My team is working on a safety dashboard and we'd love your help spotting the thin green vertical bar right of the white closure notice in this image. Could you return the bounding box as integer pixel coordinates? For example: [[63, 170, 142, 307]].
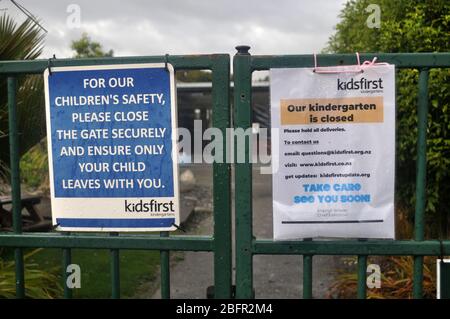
[[413, 69, 429, 298]]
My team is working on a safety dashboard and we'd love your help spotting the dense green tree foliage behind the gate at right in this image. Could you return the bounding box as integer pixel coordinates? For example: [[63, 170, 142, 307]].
[[325, 0, 450, 235]]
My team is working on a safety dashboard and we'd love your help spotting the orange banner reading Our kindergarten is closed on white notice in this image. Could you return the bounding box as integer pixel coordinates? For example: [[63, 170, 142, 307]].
[[280, 96, 384, 125]]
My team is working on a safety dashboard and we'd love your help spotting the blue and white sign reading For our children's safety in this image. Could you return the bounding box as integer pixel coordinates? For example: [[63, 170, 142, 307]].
[[44, 63, 179, 232]]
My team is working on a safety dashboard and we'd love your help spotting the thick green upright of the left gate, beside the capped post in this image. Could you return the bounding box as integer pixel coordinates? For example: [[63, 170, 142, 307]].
[[212, 55, 232, 299]]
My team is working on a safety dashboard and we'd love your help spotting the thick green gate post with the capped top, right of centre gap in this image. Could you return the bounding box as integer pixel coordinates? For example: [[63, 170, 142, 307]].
[[233, 46, 254, 298]]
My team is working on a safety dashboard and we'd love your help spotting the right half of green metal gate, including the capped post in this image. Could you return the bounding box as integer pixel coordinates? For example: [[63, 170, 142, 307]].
[[233, 46, 450, 298]]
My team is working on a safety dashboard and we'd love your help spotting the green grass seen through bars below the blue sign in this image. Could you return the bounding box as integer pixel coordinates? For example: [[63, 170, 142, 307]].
[[25, 249, 159, 298]]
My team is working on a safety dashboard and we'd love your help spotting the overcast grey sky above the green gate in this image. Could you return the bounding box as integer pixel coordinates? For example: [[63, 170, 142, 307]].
[[0, 0, 346, 58]]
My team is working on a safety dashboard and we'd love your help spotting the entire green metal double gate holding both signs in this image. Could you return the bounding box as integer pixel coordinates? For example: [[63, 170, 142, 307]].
[[0, 50, 450, 298]]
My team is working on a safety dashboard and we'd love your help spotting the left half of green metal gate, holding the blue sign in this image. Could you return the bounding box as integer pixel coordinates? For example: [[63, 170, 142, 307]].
[[0, 54, 232, 298]]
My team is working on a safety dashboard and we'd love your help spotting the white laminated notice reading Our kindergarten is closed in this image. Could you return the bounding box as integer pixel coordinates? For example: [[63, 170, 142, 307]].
[[270, 64, 395, 240]]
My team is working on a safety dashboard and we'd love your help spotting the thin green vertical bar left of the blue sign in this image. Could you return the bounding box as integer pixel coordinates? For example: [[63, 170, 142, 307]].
[[8, 77, 25, 298]]
